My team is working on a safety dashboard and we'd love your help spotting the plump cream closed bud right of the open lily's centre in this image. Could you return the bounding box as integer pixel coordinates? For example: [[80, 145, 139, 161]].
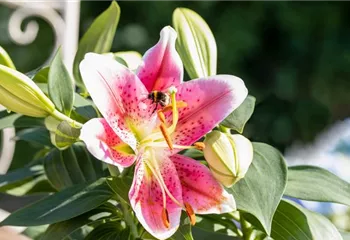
[[203, 131, 253, 187]]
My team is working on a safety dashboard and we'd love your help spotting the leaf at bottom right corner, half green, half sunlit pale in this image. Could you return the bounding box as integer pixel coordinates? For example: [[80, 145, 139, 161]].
[[271, 200, 342, 240]]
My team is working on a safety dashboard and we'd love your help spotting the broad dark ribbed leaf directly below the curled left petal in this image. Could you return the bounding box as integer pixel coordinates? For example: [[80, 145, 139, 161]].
[[44, 143, 103, 190]]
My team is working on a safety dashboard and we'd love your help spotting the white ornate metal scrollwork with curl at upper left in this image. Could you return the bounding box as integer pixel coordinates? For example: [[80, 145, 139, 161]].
[[0, 0, 80, 174]]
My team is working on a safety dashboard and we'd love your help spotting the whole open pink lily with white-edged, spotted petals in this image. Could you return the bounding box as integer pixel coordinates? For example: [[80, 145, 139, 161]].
[[80, 27, 247, 239]]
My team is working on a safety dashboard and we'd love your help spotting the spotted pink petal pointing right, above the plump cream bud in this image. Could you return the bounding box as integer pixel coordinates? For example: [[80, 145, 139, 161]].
[[171, 75, 248, 145]]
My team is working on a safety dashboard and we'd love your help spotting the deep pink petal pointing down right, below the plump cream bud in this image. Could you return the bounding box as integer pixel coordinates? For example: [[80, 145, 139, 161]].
[[170, 154, 236, 214]]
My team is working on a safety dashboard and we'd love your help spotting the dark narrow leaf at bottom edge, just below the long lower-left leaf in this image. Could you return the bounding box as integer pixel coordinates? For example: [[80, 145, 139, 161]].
[[41, 202, 117, 240]]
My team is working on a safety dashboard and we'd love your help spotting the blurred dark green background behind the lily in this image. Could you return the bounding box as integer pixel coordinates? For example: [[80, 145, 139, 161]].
[[0, 0, 350, 154]]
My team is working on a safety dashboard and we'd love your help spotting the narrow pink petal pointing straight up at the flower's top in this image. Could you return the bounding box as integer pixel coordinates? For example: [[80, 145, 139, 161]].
[[137, 26, 183, 91]]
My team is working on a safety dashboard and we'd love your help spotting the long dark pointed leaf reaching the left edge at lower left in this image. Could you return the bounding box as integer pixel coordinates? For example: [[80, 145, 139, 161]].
[[1, 178, 113, 226]]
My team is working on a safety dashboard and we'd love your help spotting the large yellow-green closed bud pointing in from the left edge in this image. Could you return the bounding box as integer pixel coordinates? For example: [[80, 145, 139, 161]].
[[0, 65, 55, 117]]
